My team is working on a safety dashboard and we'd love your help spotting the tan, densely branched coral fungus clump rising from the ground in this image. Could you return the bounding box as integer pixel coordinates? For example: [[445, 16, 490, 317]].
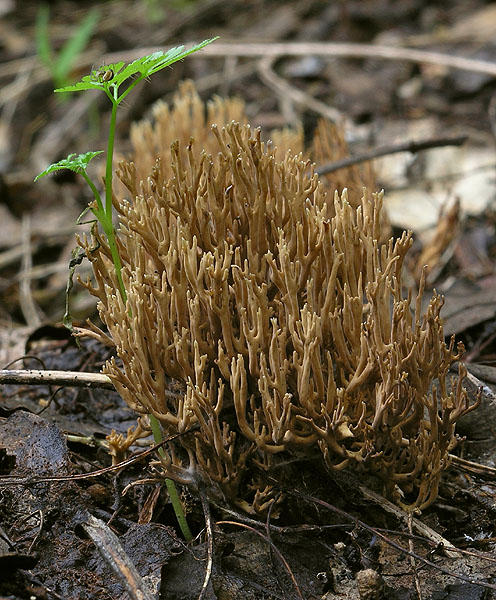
[[81, 82, 476, 511]]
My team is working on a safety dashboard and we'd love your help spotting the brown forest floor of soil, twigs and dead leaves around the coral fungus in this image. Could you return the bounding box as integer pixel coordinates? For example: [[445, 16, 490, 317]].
[[0, 0, 496, 600]]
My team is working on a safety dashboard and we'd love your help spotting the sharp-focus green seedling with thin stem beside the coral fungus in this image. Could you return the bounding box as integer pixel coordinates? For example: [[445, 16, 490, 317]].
[[35, 38, 217, 541]]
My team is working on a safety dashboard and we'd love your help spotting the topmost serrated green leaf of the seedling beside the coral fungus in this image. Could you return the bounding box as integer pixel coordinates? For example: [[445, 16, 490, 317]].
[[55, 37, 217, 92]]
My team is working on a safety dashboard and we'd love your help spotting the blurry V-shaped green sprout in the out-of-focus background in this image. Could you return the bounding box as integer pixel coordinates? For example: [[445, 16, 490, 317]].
[[35, 4, 100, 88]]
